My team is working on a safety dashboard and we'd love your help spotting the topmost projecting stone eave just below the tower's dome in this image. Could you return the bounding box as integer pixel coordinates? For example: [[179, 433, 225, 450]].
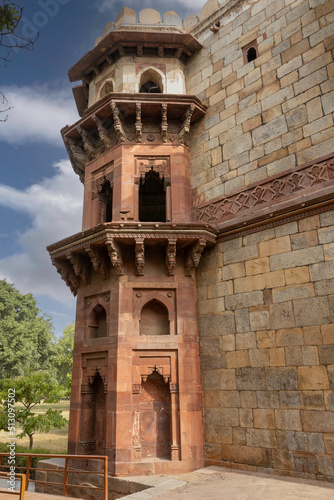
[[68, 28, 202, 82]]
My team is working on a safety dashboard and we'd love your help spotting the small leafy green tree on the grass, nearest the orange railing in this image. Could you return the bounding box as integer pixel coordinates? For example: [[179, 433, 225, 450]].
[[0, 372, 68, 449]]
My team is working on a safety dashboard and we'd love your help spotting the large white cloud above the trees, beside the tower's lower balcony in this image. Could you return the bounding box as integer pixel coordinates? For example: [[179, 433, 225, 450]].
[[0, 160, 83, 304]]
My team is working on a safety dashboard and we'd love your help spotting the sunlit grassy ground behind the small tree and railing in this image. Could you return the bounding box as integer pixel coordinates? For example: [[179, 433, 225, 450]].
[[0, 401, 70, 454]]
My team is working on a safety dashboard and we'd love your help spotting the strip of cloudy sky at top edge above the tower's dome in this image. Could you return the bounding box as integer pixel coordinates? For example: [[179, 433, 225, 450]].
[[97, 0, 206, 15]]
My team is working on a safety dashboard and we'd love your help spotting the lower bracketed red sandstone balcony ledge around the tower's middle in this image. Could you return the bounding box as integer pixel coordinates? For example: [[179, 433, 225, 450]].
[[48, 222, 216, 295]]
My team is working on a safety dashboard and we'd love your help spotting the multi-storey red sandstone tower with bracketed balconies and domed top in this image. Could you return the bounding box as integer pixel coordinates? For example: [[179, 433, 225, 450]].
[[48, 8, 215, 475]]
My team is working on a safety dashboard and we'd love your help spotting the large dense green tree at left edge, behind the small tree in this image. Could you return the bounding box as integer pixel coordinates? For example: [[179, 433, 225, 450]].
[[0, 280, 56, 378]]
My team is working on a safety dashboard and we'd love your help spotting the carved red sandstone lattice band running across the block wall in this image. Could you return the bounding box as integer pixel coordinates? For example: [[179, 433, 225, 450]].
[[196, 153, 334, 238]]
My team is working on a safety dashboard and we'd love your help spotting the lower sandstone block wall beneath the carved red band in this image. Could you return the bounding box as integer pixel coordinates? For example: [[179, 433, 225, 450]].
[[198, 211, 334, 480]]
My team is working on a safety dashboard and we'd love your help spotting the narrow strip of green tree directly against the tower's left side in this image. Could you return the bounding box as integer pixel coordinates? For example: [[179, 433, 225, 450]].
[[54, 323, 74, 393]]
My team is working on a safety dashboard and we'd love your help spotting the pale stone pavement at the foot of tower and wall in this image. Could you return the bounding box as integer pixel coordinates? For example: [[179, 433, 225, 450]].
[[123, 467, 334, 500]]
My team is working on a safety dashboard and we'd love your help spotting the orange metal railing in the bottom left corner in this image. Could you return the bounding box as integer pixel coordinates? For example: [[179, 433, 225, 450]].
[[0, 453, 108, 500]]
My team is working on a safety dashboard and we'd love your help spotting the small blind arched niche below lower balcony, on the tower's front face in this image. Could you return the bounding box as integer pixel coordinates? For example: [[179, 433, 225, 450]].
[[140, 300, 170, 335]]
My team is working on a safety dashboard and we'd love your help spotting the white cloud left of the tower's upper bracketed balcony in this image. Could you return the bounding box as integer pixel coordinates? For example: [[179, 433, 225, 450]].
[[0, 85, 79, 146]]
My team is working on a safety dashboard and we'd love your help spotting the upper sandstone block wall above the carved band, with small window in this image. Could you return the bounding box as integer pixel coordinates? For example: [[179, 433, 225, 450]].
[[186, 0, 334, 203]]
